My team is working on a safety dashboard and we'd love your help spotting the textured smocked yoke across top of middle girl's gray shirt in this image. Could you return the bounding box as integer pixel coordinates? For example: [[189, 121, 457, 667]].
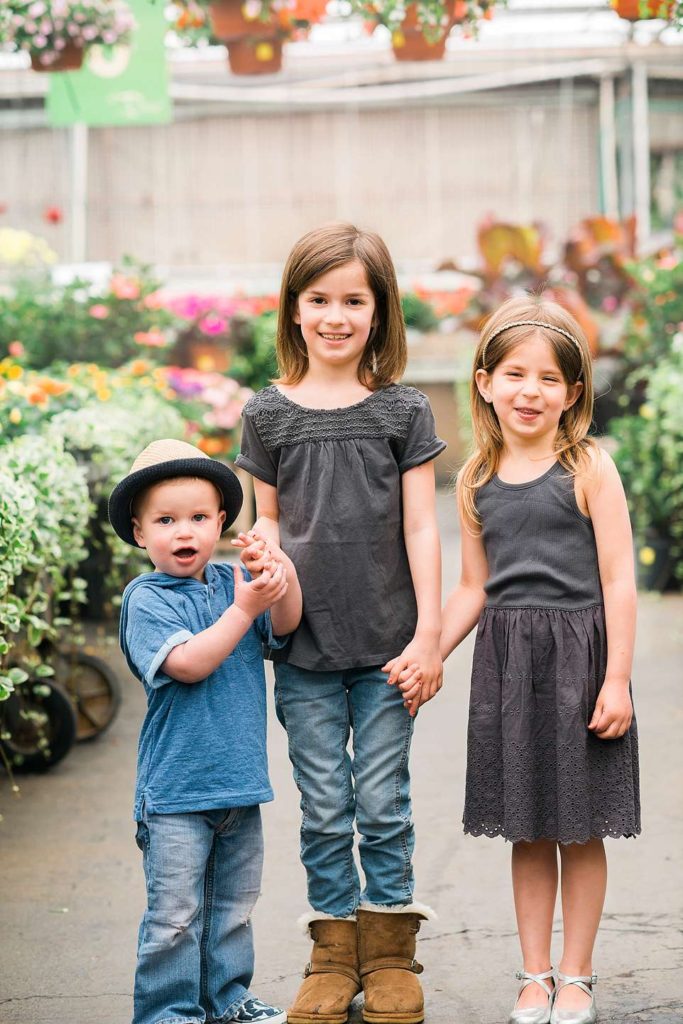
[[245, 384, 427, 451]]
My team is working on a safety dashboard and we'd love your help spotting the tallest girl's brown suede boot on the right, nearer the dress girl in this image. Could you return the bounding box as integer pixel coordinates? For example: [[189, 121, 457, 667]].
[[357, 910, 426, 1024]]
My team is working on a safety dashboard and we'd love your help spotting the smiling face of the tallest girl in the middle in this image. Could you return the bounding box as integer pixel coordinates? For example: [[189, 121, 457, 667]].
[[294, 260, 375, 367]]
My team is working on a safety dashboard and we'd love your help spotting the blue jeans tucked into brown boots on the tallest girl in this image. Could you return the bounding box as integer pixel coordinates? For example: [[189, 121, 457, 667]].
[[275, 664, 415, 918]]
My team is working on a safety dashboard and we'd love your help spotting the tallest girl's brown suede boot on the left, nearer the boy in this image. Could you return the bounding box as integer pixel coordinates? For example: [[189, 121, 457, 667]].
[[287, 920, 360, 1024]]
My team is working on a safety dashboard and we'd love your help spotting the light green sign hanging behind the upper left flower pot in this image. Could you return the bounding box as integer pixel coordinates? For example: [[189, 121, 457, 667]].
[[46, 0, 171, 126]]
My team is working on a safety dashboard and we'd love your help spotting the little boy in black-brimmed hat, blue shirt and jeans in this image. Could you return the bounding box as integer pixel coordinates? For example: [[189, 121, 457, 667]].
[[109, 440, 301, 1024]]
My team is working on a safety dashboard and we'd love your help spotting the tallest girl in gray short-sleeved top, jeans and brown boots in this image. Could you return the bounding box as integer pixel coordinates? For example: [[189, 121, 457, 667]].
[[237, 224, 445, 1024]]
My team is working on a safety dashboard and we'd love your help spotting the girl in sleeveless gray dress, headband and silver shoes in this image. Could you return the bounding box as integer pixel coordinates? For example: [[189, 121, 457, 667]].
[[441, 297, 640, 1024]]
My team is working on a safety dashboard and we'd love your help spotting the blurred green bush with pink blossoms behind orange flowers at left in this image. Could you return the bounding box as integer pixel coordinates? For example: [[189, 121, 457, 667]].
[[0, 260, 178, 369]]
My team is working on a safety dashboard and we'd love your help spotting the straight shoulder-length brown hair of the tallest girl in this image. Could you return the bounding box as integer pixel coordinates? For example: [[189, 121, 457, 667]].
[[276, 223, 408, 391]]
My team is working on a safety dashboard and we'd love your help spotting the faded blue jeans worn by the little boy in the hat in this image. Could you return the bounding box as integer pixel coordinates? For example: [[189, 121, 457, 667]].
[[133, 807, 263, 1024]]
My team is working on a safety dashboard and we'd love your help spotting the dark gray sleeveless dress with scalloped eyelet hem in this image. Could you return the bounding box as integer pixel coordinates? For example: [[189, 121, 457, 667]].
[[463, 463, 640, 843]]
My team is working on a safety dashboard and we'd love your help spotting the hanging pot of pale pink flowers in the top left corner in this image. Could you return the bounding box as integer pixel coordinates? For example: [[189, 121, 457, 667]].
[[0, 0, 135, 72]]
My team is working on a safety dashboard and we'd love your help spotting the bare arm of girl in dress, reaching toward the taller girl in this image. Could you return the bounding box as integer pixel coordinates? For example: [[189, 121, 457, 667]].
[[441, 480, 488, 660]]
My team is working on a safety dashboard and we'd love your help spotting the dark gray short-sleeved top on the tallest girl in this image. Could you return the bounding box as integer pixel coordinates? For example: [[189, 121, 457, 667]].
[[237, 384, 445, 671]]
